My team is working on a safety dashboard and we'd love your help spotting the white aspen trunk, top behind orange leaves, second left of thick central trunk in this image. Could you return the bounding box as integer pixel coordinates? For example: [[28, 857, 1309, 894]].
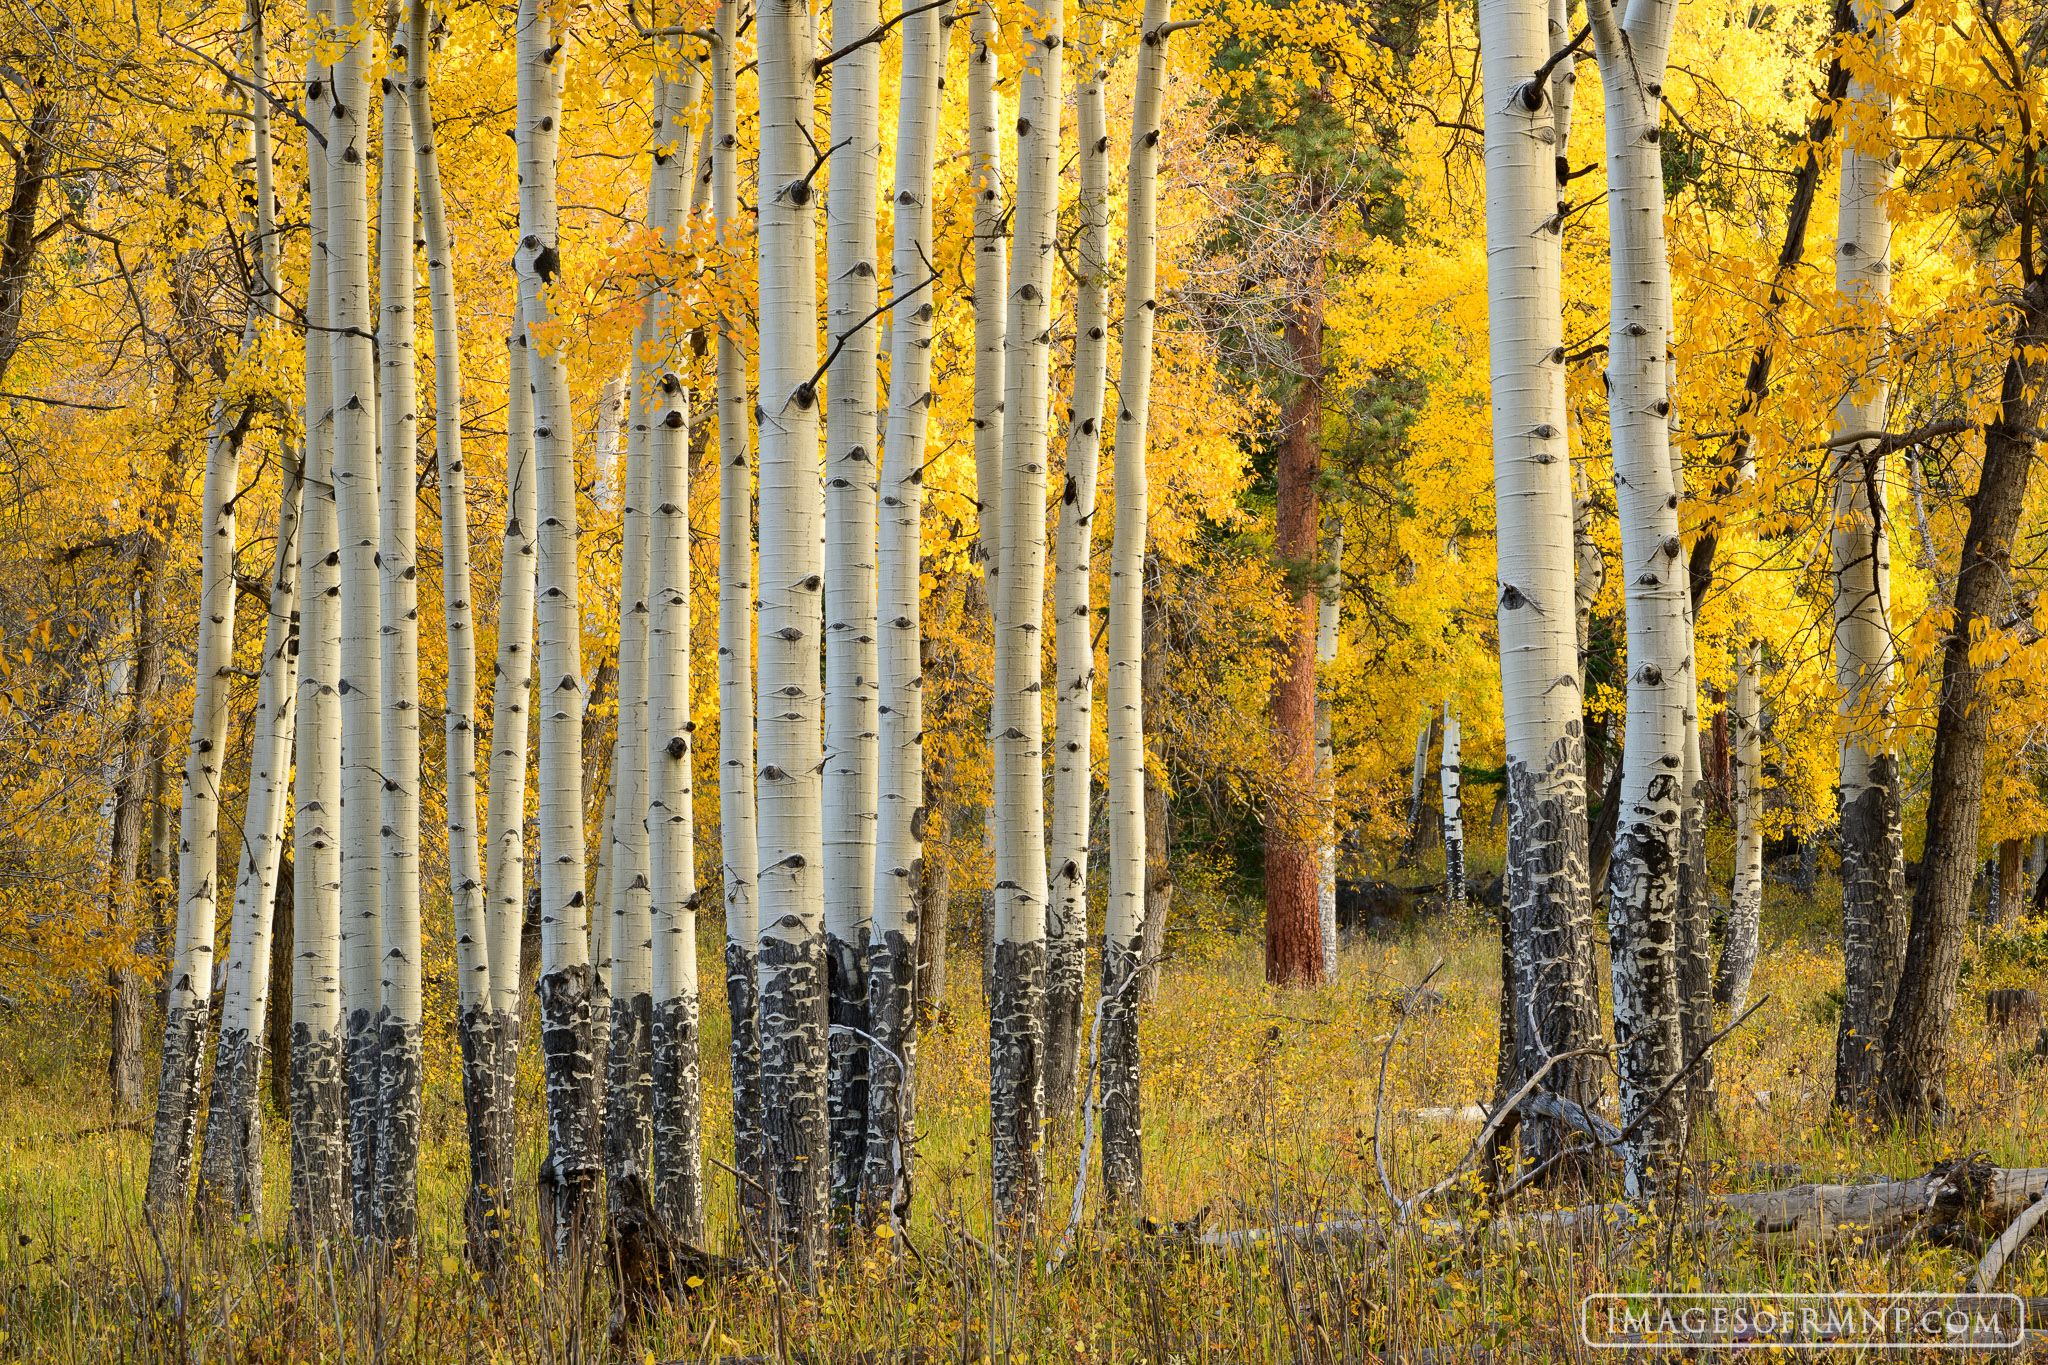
[[643, 368, 707, 1246]]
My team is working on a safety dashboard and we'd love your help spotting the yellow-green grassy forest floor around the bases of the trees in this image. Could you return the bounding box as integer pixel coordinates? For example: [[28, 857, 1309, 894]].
[[0, 859, 2048, 1365]]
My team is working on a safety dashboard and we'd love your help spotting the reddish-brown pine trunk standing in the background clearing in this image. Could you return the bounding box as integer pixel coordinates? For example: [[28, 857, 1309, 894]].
[[1261, 290, 1323, 986]]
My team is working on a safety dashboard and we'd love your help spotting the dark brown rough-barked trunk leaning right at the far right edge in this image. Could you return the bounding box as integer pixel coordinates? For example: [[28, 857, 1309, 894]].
[[1878, 298, 2048, 1119]]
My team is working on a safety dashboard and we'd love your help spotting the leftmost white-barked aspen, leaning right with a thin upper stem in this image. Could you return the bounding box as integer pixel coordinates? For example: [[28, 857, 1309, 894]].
[[143, 0, 270, 1224]]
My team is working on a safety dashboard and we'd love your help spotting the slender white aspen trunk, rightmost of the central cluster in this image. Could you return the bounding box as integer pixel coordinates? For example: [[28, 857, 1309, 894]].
[[1098, 0, 1174, 1209]]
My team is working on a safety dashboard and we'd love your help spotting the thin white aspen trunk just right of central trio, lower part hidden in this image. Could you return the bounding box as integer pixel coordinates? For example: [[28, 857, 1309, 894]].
[[967, 0, 1010, 597]]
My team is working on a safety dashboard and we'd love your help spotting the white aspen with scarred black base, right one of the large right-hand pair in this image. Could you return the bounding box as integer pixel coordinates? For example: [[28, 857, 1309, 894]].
[[1587, 0, 1692, 1197]]
